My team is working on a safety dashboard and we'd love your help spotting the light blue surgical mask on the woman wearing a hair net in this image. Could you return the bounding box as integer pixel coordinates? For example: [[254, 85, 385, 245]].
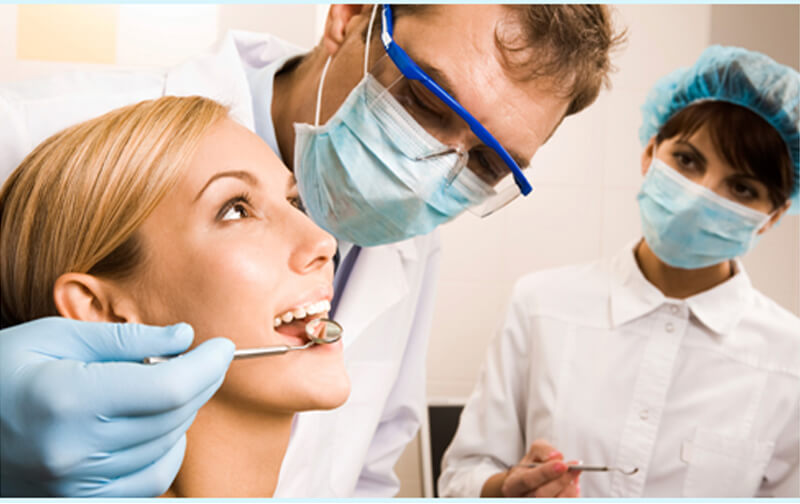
[[638, 157, 770, 269]]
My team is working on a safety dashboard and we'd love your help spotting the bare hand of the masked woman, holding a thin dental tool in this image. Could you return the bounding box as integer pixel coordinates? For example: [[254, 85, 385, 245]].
[[482, 439, 580, 497]]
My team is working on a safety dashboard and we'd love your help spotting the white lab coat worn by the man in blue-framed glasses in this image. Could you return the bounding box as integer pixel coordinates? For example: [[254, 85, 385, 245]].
[[0, 32, 440, 498]]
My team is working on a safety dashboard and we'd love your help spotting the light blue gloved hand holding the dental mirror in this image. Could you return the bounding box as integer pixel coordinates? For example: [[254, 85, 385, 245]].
[[0, 317, 234, 497]]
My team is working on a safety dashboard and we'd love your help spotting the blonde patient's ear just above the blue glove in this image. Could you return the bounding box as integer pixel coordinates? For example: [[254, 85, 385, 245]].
[[53, 273, 140, 323]]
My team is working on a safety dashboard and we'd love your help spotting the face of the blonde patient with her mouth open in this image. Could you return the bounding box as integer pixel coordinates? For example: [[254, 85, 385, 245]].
[[132, 119, 349, 412]]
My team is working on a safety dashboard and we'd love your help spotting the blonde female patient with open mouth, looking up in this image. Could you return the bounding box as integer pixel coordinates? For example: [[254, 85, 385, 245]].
[[0, 97, 349, 497]]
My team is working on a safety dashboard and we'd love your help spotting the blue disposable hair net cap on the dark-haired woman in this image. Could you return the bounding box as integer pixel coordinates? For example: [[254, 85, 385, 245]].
[[639, 46, 800, 214]]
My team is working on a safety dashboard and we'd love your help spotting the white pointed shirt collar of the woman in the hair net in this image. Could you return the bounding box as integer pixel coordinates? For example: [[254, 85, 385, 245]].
[[609, 240, 753, 335]]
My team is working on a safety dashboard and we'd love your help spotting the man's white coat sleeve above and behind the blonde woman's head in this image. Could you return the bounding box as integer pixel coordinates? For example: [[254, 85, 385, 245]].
[[0, 70, 164, 181]]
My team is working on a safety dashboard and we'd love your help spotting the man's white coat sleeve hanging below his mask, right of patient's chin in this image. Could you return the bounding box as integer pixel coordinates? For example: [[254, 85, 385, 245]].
[[352, 234, 441, 498]]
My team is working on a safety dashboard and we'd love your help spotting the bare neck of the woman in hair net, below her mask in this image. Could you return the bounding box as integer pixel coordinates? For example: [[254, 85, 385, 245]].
[[634, 239, 734, 299]]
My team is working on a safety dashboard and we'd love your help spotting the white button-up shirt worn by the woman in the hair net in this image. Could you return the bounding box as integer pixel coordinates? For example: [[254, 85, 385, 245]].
[[439, 244, 800, 498]]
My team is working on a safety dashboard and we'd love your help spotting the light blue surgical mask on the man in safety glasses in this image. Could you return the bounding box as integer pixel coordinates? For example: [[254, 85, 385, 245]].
[[294, 50, 494, 246]]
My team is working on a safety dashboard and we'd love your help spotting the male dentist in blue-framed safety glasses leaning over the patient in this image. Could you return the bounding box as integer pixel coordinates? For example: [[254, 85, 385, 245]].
[[0, 5, 616, 497]]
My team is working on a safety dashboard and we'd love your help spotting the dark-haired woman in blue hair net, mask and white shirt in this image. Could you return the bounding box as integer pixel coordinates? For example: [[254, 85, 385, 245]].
[[439, 46, 800, 497]]
